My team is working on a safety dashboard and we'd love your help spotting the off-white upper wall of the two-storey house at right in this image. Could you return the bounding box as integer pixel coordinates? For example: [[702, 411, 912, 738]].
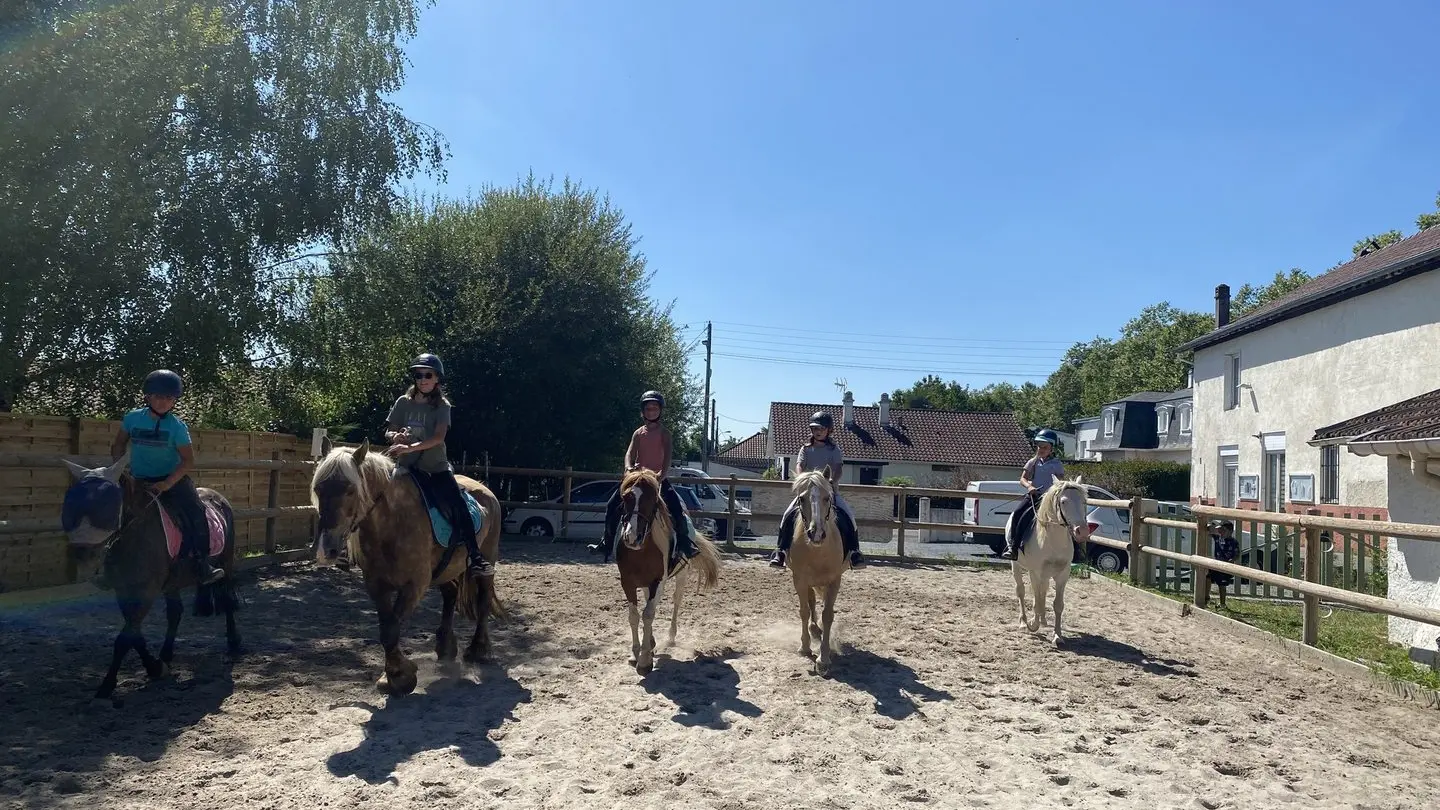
[[1191, 272, 1440, 507]]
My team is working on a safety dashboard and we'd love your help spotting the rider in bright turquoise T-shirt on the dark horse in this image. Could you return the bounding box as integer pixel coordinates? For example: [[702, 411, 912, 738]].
[[108, 369, 225, 587]]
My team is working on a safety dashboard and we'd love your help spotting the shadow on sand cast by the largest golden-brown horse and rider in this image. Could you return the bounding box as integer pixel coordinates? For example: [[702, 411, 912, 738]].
[[325, 667, 530, 784]]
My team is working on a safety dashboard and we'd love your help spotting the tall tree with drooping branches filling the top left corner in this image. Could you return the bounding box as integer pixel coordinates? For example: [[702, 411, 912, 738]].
[[0, 0, 445, 412]]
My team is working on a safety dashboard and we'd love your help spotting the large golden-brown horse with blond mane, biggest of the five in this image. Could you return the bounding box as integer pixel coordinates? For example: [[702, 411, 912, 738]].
[[311, 440, 503, 695]]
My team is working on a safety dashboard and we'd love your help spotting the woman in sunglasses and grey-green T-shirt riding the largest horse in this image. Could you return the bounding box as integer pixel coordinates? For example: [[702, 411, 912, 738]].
[[384, 353, 494, 577]]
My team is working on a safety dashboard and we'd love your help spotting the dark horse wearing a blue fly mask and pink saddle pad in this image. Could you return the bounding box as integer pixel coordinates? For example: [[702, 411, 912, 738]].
[[60, 453, 240, 698]]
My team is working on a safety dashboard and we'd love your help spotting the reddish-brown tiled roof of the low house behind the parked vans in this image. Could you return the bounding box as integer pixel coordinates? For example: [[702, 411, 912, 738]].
[[770, 402, 1032, 467]]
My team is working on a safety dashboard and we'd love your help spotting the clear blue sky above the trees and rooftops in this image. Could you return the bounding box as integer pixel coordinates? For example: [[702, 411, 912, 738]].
[[396, 0, 1440, 437]]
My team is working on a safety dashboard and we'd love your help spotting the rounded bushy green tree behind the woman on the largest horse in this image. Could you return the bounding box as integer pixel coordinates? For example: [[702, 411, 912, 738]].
[[275, 177, 698, 470]]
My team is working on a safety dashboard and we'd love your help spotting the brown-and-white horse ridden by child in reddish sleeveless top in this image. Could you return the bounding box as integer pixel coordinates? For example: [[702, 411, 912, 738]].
[[615, 470, 720, 675]]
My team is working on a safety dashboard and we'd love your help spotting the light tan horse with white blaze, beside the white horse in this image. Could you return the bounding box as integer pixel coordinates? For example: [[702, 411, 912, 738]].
[[785, 470, 850, 676]]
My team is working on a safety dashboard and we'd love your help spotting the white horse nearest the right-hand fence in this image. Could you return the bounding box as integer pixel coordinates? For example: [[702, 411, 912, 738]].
[[1005, 476, 1090, 644]]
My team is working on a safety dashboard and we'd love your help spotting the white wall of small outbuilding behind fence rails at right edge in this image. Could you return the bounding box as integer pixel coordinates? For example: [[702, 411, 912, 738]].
[[1382, 458, 1440, 660]]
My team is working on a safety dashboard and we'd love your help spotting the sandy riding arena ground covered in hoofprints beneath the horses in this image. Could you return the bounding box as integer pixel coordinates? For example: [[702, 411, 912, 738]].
[[0, 543, 1440, 810]]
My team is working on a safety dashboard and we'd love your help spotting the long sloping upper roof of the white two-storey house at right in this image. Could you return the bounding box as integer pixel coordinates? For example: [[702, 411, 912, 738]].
[[1179, 226, 1440, 352]]
